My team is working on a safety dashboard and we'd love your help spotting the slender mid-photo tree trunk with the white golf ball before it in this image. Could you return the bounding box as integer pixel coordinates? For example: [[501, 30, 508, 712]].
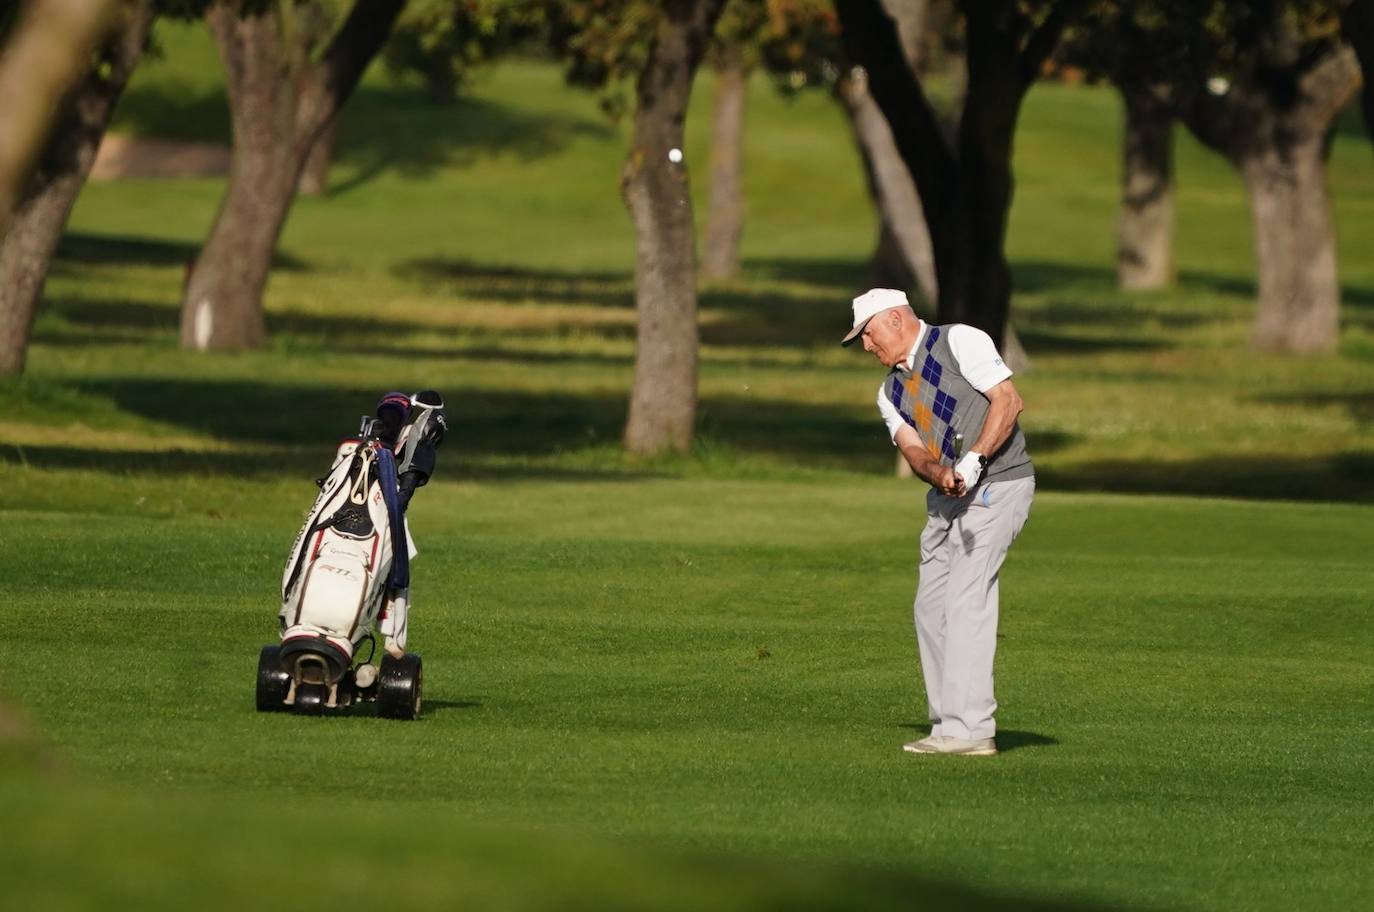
[[621, 0, 724, 455]]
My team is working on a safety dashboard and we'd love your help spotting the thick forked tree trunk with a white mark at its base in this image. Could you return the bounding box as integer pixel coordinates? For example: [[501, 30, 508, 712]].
[[181, 0, 405, 352]]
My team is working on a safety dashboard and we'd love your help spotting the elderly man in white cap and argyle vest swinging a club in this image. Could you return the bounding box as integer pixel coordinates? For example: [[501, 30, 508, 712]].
[[842, 288, 1035, 757]]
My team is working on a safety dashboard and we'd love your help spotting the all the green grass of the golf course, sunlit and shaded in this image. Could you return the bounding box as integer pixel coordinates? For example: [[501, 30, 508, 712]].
[[0, 19, 1374, 909]]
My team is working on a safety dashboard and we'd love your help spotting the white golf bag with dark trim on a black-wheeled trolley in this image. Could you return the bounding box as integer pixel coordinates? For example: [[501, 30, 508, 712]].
[[257, 390, 448, 720]]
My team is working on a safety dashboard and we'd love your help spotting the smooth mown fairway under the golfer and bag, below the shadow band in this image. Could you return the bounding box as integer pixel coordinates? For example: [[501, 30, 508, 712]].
[[0, 472, 1374, 908]]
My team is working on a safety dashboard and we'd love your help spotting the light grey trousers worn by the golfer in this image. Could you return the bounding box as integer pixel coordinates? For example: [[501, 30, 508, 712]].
[[915, 478, 1035, 740]]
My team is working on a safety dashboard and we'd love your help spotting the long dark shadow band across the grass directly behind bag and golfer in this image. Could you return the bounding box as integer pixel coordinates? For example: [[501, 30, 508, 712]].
[[8, 378, 1374, 503]]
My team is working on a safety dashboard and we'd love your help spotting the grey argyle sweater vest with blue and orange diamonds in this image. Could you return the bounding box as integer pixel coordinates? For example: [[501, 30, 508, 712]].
[[882, 326, 1035, 481]]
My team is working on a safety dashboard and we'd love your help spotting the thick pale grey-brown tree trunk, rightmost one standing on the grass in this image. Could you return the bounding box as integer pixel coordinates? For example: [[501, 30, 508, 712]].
[[1241, 137, 1341, 353]]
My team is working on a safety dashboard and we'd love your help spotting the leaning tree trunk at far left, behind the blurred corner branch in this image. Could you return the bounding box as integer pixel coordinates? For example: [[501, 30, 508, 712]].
[[0, 0, 154, 376]]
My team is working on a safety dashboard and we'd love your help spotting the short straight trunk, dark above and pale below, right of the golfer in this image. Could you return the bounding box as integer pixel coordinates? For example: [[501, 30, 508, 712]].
[[1117, 82, 1173, 290]]
